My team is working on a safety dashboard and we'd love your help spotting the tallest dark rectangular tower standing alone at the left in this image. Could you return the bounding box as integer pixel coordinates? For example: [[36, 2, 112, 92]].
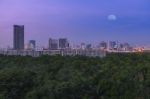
[[13, 25, 24, 50]]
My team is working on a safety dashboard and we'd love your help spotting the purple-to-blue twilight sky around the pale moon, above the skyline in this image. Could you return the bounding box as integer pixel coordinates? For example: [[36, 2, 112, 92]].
[[0, 0, 150, 47]]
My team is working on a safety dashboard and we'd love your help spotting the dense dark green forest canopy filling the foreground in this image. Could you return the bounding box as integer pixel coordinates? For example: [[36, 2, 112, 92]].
[[0, 53, 150, 99]]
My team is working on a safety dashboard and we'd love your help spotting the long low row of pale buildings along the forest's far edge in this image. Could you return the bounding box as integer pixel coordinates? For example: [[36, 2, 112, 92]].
[[0, 49, 106, 57]]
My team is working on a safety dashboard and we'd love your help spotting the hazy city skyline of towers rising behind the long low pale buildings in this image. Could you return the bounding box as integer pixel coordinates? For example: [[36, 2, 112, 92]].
[[0, 24, 148, 50]]
